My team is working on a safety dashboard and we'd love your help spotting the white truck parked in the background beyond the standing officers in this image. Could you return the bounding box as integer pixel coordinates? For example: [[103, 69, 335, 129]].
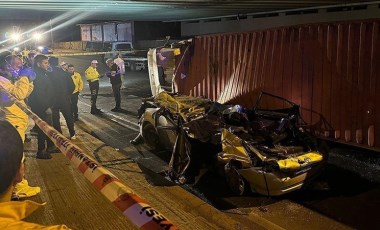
[[104, 42, 148, 71]]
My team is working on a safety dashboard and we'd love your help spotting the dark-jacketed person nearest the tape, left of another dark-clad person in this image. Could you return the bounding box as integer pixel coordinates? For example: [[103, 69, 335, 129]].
[[29, 54, 55, 159]]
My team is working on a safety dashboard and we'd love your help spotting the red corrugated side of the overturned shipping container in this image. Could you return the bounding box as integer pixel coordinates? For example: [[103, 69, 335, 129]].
[[175, 20, 380, 147]]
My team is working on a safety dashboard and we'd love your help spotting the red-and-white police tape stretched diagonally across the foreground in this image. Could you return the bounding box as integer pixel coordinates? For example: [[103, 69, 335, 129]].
[[0, 85, 178, 230]]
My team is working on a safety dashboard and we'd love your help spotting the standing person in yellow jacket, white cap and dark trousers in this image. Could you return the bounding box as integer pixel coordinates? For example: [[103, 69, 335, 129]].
[[85, 60, 100, 114]]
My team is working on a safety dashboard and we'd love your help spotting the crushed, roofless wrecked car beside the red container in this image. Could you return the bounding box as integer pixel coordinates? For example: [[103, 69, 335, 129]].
[[139, 92, 324, 196]]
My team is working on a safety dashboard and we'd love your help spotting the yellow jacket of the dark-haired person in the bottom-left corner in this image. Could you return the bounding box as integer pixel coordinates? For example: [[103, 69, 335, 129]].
[[0, 200, 69, 230]]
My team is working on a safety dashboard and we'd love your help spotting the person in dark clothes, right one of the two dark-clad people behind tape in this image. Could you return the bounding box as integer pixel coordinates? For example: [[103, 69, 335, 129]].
[[49, 57, 77, 140]]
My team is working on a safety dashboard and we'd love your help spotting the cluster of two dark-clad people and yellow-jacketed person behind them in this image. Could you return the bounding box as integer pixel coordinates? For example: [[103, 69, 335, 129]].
[[28, 55, 83, 159]]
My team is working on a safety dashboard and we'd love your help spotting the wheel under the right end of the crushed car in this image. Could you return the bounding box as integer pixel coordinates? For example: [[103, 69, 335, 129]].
[[224, 161, 249, 196]]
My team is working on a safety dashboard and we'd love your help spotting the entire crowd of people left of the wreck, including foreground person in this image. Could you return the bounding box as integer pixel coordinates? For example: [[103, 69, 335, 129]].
[[0, 52, 124, 229]]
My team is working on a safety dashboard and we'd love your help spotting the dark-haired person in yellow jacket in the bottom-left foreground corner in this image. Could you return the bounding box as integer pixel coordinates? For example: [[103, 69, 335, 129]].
[[0, 120, 68, 229]]
